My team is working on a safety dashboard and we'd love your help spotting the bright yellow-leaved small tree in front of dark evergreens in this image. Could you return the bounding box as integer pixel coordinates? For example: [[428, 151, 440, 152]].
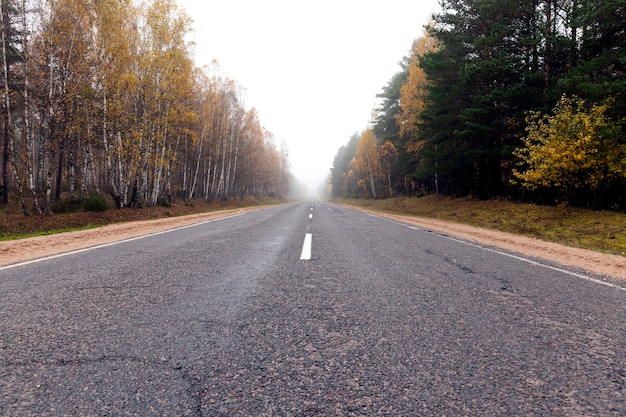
[[513, 96, 626, 190]]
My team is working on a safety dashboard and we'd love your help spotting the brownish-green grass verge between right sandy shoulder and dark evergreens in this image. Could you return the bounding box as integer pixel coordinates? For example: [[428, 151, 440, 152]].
[[340, 196, 626, 256]]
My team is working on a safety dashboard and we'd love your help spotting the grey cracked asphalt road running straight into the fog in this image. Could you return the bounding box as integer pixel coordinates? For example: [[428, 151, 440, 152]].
[[0, 202, 626, 416]]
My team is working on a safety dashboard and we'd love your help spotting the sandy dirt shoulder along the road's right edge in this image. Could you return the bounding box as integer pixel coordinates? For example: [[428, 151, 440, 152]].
[[348, 206, 626, 279]]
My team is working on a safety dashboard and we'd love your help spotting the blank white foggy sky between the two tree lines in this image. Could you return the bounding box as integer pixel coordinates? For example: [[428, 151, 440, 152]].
[[178, 0, 438, 192]]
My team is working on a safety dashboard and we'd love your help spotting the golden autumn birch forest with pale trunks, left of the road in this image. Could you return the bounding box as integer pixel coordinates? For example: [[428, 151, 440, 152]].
[[0, 0, 290, 215]]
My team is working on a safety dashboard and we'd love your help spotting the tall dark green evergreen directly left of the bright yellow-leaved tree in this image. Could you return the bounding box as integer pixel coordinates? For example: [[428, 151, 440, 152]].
[[420, 0, 541, 198]]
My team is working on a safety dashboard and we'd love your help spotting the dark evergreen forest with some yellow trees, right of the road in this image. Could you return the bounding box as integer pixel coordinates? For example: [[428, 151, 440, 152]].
[[330, 0, 626, 210]]
